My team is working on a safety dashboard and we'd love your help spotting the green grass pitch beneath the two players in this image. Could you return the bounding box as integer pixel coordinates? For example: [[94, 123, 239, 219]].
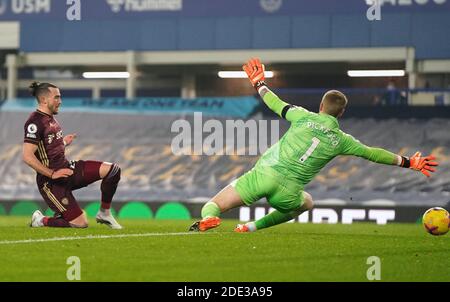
[[0, 216, 450, 281]]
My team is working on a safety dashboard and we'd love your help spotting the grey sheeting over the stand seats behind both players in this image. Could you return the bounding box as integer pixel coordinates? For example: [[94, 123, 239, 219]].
[[0, 99, 450, 205]]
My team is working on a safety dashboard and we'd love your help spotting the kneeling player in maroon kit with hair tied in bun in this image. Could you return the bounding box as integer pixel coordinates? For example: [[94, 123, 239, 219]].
[[23, 82, 122, 229]]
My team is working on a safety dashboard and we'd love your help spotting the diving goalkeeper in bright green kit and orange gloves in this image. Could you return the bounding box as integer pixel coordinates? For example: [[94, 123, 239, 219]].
[[189, 59, 438, 232]]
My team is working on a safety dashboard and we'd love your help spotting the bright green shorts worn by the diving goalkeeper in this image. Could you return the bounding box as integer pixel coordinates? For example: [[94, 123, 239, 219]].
[[231, 168, 304, 213]]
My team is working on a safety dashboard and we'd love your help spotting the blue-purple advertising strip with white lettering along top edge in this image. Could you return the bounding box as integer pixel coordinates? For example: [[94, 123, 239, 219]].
[[0, 0, 450, 20]]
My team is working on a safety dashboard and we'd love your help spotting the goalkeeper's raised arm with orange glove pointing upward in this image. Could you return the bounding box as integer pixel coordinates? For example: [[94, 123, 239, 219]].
[[242, 58, 308, 122]]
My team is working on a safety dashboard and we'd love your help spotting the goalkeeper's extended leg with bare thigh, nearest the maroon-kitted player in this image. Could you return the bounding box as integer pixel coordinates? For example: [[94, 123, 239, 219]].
[[189, 185, 244, 232]]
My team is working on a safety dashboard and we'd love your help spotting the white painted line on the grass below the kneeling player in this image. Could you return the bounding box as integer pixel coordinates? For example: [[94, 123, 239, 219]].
[[0, 232, 199, 245]]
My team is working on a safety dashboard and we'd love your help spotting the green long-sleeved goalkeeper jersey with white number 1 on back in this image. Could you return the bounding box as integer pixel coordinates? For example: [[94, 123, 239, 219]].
[[256, 90, 397, 187]]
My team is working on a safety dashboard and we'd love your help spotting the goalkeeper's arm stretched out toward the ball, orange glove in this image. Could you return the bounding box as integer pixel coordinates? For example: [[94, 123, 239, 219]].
[[342, 135, 438, 177]]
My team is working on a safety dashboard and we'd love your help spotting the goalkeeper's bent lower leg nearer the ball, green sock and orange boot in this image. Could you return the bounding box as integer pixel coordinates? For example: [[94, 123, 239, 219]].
[[235, 192, 314, 233]]
